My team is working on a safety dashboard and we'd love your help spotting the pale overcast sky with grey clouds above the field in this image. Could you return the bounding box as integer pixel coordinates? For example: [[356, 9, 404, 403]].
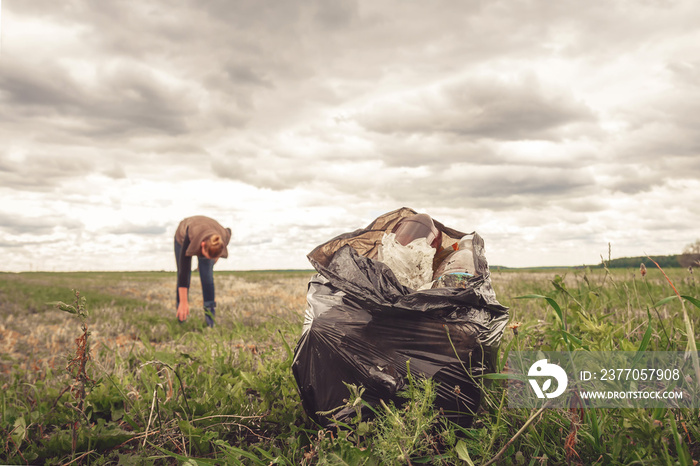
[[0, 0, 700, 271]]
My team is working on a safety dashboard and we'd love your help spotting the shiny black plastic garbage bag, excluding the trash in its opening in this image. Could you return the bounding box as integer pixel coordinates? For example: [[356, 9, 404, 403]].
[[292, 208, 508, 427]]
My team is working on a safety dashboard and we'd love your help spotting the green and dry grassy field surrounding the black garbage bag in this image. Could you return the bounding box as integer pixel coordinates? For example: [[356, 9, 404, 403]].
[[0, 269, 700, 465]]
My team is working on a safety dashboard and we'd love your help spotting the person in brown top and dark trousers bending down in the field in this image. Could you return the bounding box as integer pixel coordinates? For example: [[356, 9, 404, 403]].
[[175, 215, 231, 327]]
